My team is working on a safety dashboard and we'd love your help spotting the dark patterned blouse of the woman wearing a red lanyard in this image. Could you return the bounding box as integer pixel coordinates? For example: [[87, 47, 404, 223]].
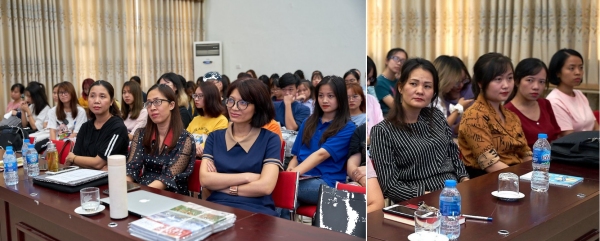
[[127, 128, 200, 195]]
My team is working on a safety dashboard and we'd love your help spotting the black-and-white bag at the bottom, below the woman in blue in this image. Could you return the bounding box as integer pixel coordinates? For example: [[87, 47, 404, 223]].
[[313, 185, 367, 238]]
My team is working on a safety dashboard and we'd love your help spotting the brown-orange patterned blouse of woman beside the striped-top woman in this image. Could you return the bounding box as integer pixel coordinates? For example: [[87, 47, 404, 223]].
[[458, 94, 531, 170]]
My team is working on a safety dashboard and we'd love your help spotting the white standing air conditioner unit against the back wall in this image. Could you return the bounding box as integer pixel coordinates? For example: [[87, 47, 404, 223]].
[[194, 41, 223, 81]]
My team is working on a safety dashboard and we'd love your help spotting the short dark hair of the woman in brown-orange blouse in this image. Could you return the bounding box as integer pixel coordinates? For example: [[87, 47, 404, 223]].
[[471, 52, 514, 99]]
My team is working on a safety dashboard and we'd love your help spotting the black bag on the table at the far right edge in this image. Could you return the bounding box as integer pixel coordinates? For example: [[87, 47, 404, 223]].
[[550, 131, 600, 168]]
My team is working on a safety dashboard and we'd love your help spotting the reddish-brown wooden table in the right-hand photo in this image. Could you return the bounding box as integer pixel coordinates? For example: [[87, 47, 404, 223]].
[[367, 162, 599, 241]]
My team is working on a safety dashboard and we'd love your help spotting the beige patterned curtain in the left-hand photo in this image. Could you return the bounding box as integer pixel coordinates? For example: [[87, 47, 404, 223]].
[[0, 0, 202, 110]]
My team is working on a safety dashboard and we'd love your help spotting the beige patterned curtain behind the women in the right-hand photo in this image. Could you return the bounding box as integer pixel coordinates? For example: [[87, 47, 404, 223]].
[[367, 0, 600, 89]]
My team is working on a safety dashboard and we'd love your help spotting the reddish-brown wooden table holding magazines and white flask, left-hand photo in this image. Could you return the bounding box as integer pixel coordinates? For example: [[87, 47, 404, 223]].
[[0, 168, 361, 241]]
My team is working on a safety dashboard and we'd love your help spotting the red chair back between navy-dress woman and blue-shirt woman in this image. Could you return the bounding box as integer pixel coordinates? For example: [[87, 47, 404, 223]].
[[271, 171, 299, 220]]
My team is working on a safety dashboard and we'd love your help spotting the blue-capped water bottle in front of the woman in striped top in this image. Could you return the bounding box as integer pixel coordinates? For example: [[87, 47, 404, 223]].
[[440, 180, 461, 240]]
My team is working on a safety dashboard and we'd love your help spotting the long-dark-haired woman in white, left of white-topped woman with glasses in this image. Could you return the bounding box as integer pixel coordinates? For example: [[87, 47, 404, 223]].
[[21, 81, 50, 131]]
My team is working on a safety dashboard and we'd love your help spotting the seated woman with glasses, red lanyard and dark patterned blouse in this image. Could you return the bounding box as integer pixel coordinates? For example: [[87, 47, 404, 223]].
[[127, 85, 196, 195]]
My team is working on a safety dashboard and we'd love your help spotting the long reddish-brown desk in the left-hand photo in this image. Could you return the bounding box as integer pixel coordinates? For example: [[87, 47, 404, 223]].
[[0, 168, 360, 240]]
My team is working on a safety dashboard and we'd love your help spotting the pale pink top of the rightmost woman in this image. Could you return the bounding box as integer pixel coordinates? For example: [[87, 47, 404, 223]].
[[546, 89, 596, 131]]
